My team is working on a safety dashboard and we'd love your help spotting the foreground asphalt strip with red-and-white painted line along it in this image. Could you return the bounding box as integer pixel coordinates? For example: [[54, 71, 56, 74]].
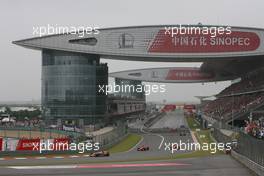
[[0, 155, 251, 176]]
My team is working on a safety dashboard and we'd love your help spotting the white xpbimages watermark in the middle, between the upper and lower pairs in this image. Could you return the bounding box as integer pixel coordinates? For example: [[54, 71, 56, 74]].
[[98, 83, 166, 95]]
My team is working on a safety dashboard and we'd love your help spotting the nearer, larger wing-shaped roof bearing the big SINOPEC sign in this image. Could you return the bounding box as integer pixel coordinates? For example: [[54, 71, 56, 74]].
[[13, 25, 264, 80]]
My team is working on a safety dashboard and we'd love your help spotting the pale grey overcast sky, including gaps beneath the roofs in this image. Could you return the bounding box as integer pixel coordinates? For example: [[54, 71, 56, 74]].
[[0, 0, 264, 102]]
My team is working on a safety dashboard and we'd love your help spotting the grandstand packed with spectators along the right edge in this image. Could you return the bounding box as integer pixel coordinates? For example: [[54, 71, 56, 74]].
[[203, 68, 264, 127]]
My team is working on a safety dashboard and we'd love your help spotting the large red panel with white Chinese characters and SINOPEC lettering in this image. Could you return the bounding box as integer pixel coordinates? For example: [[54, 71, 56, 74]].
[[148, 29, 260, 53]]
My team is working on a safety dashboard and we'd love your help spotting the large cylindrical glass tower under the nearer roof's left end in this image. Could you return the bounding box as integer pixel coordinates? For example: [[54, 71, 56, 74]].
[[41, 50, 108, 125]]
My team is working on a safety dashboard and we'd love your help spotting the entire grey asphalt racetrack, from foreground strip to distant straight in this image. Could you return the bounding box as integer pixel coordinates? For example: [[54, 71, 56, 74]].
[[0, 112, 254, 176]]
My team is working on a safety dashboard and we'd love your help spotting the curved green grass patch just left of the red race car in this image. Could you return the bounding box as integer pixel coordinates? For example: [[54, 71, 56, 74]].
[[109, 134, 142, 153]]
